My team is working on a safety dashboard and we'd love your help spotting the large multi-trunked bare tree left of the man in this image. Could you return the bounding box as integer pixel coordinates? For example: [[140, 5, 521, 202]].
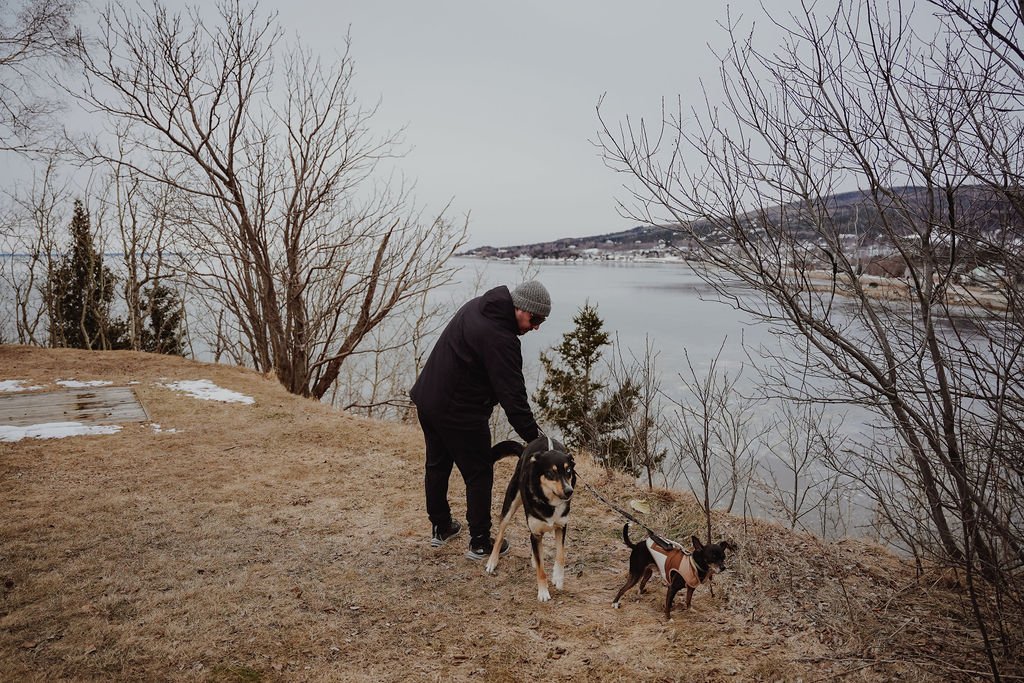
[[77, 0, 465, 397]]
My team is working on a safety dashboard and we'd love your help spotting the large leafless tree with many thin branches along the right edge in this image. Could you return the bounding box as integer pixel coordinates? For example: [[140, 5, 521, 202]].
[[601, 0, 1024, 677]]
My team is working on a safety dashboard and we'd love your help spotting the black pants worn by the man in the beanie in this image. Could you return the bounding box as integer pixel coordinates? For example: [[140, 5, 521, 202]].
[[420, 414, 495, 539]]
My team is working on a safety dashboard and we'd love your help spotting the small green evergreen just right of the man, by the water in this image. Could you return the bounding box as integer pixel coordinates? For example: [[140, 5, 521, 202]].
[[534, 303, 639, 475]]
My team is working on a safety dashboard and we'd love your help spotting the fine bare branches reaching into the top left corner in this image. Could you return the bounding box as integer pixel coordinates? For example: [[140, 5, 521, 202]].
[[0, 0, 79, 151]]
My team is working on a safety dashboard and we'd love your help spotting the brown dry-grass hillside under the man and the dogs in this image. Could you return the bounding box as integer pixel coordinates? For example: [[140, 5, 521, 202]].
[[0, 346, 1007, 681]]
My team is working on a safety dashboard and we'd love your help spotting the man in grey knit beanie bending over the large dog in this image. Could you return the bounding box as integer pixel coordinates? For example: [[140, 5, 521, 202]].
[[410, 281, 551, 559]]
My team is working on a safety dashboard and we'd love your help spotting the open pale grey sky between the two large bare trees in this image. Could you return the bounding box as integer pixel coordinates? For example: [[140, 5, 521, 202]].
[[261, 0, 795, 246]]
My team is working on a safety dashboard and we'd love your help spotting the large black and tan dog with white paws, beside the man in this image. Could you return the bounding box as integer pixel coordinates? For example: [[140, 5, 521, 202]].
[[485, 436, 577, 602]]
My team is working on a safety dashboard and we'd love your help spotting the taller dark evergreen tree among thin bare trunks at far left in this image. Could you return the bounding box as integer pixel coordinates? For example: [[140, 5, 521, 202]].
[[47, 200, 123, 349]]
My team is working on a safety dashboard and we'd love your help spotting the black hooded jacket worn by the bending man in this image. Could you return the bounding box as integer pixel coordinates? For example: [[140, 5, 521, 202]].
[[410, 287, 540, 442]]
